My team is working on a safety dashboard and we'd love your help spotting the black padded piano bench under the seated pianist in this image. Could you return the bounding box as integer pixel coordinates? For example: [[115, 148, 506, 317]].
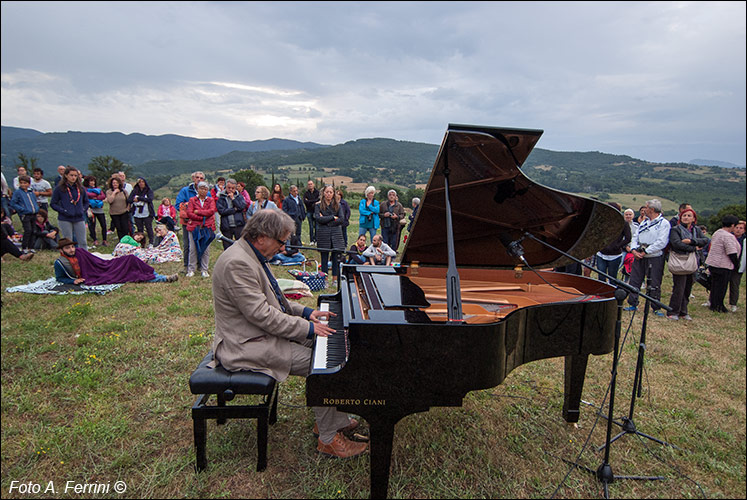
[[189, 351, 279, 472]]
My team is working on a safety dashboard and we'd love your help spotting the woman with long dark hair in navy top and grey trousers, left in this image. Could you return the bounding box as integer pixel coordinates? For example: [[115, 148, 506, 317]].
[[49, 166, 88, 250]]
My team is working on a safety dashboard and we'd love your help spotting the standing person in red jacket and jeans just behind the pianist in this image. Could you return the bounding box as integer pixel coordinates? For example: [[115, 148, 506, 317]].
[[187, 181, 217, 278]]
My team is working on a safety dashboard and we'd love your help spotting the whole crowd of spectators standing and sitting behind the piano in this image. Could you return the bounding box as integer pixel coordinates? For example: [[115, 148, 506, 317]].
[[2, 165, 747, 321]]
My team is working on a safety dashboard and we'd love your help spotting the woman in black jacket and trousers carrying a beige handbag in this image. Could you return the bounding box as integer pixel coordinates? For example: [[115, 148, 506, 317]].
[[667, 208, 708, 321]]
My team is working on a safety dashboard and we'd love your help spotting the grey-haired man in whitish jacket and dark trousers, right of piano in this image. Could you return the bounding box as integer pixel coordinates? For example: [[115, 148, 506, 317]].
[[625, 199, 670, 317]]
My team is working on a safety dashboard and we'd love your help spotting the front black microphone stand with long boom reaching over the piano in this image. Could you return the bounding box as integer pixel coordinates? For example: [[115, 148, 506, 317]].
[[520, 232, 671, 498]]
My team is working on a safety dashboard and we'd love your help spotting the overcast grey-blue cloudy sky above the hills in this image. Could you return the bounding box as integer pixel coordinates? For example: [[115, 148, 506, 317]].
[[1, 1, 747, 165]]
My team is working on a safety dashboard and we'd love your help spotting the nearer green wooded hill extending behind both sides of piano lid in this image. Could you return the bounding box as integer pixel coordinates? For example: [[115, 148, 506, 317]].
[[135, 138, 745, 215]]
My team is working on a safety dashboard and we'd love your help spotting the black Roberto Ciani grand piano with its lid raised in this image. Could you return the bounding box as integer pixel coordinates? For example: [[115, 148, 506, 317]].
[[306, 125, 624, 498]]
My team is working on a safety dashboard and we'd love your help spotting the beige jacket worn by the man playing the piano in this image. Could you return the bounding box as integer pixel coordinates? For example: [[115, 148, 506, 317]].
[[213, 238, 309, 382]]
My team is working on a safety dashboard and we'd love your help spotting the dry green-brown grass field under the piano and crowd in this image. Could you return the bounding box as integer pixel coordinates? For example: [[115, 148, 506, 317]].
[[0, 210, 747, 498]]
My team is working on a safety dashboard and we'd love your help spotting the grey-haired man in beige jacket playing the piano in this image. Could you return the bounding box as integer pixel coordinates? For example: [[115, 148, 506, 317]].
[[213, 210, 368, 458]]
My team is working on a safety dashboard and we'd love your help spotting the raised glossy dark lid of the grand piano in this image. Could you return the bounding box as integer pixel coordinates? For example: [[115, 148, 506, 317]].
[[402, 124, 625, 268]]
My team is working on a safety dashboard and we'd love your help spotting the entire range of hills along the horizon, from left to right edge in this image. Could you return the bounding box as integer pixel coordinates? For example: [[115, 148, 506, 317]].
[[1, 127, 745, 214]]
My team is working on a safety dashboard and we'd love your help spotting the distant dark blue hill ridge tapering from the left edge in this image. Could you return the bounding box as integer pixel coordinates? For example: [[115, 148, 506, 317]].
[[0, 126, 325, 172]]
